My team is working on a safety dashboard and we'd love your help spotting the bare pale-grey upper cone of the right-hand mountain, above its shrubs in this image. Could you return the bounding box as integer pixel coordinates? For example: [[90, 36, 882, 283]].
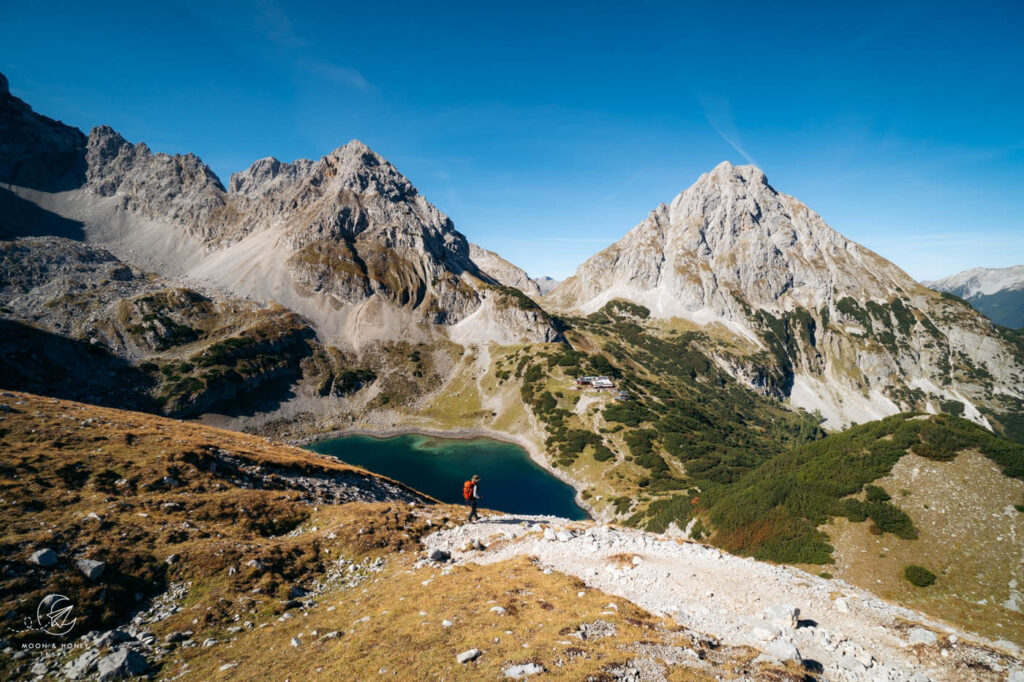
[[552, 162, 916, 319]]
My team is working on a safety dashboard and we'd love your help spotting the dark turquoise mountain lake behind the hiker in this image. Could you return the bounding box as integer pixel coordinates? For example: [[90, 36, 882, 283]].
[[307, 435, 587, 519]]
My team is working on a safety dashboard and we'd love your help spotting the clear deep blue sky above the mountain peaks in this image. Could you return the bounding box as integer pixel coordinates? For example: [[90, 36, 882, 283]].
[[0, 0, 1024, 279]]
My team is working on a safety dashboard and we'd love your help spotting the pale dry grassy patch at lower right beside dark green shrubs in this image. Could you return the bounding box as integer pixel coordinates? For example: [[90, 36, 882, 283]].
[[823, 451, 1024, 641]]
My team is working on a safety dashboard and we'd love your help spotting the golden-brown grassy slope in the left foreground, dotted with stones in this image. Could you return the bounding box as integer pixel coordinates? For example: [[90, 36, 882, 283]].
[[0, 393, 790, 679]]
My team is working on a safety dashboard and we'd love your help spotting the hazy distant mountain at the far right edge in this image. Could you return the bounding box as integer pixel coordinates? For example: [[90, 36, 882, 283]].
[[921, 265, 1024, 329]]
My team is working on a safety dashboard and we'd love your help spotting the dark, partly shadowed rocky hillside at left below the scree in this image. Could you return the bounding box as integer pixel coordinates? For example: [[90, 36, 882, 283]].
[[0, 238, 339, 416]]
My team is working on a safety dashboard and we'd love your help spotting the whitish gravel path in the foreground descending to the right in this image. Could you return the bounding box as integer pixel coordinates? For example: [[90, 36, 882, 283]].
[[424, 515, 1024, 682]]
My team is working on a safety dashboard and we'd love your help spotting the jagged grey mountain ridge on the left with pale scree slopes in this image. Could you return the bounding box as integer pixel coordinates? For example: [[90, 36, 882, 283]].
[[0, 74, 559, 348]]
